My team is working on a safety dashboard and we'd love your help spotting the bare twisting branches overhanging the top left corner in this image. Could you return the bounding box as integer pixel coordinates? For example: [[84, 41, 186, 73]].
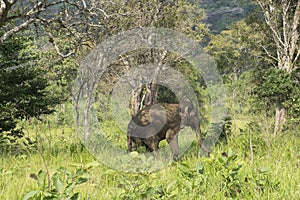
[[0, 0, 109, 58]]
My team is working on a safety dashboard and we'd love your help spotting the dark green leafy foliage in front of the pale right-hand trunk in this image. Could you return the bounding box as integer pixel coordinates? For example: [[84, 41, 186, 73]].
[[254, 68, 300, 128]]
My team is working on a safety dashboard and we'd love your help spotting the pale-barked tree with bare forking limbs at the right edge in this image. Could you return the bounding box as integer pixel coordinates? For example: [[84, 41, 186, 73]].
[[256, 0, 300, 135]]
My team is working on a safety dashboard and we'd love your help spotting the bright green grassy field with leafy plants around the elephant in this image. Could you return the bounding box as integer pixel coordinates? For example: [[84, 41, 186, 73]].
[[0, 114, 300, 200]]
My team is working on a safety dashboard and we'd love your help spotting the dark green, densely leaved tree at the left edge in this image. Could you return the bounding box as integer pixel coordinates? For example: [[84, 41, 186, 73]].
[[0, 37, 57, 132]]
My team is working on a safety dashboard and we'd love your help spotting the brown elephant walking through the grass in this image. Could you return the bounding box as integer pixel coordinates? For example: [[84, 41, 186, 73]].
[[127, 103, 209, 161]]
